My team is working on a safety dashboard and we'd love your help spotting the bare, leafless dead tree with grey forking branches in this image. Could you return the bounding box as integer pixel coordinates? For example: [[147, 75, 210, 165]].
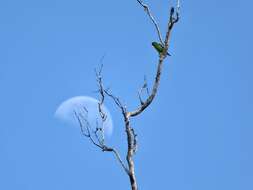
[[75, 0, 180, 190]]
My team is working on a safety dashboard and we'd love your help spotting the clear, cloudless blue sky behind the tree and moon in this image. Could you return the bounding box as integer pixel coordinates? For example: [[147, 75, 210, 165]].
[[0, 0, 253, 190]]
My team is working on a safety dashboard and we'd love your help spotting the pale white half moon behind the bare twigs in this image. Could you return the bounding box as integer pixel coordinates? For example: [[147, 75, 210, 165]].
[[54, 96, 113, 137]]
